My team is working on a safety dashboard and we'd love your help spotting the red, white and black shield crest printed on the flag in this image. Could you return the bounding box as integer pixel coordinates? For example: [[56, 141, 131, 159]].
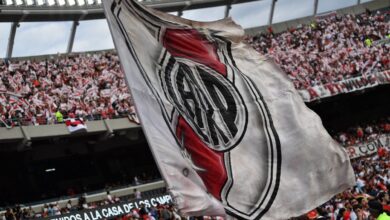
[[111, 1, 281, 219]]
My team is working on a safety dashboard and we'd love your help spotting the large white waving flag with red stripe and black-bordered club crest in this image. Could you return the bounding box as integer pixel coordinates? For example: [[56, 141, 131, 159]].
[[102, 0, 354, 219]]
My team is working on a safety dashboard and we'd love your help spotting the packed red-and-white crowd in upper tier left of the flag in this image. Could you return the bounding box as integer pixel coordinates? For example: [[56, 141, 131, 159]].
[[0, 52, 134, 126]]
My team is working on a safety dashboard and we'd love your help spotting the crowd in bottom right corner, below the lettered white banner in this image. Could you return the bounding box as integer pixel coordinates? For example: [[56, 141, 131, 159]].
[[294, 143, 390, 220]]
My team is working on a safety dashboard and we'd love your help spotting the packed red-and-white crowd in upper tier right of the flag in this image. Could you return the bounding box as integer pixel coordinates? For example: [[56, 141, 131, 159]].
[[247, 10, 390, 89]]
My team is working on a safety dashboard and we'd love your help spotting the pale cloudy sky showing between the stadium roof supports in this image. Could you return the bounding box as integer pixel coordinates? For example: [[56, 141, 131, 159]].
[[0, 0, 370, 57]]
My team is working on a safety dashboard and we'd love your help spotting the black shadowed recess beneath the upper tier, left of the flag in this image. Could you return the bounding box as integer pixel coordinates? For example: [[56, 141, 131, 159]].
[[0, 133, 165, 216]]
